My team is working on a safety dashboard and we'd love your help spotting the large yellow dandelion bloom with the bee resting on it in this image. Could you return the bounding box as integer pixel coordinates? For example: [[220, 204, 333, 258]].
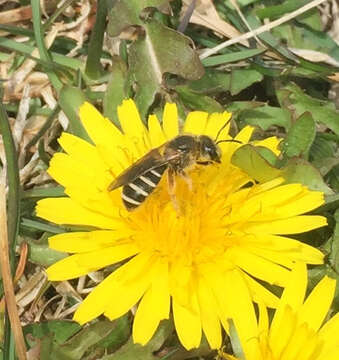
[[37, 100, 326, 349]]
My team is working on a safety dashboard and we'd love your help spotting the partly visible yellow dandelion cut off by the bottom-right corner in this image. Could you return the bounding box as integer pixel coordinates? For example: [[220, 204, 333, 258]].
[[220, 263, 339, 360]]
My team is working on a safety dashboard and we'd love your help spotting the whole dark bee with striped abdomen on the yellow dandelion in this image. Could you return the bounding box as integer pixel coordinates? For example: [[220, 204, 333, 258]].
[[108, 124, 239, 211]]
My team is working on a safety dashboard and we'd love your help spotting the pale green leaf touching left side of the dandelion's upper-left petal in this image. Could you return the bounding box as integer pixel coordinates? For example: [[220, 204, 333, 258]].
[[59, 85, 90, 141]]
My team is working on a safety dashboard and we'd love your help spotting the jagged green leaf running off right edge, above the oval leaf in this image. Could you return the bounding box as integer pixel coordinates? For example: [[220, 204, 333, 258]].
[[277, 83, 339, 135]]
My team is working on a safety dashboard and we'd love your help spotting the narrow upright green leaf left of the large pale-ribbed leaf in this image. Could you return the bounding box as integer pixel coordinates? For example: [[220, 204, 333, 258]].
[[103, 56, 128, 125]]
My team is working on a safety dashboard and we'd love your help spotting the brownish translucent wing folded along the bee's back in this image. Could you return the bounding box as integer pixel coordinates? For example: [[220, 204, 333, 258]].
[[108, 146, 179, 191]]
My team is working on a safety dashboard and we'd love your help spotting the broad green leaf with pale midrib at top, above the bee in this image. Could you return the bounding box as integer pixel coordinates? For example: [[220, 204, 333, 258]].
[[108, 0, 204, 117]]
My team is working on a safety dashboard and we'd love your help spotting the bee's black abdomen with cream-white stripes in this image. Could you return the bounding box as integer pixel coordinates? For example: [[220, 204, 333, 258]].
[[121, 164, 168, 210]]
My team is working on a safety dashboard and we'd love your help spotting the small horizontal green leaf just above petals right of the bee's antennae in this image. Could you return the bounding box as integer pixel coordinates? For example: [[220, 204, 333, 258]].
[[239, 105, 291, 130]]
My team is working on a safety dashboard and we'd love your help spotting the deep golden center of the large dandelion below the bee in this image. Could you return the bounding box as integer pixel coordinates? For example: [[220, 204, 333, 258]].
[[124, 166, 247, 266]]
